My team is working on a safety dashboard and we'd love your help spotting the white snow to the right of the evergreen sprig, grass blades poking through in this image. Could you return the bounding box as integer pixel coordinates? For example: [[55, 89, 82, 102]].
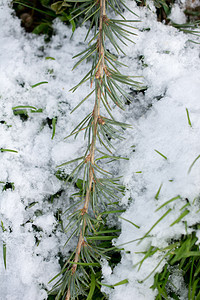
[[103, 1, 200, 300]]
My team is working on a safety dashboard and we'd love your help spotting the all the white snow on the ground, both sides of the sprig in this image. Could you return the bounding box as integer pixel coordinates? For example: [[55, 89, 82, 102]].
[[0, 0, 200, 300]]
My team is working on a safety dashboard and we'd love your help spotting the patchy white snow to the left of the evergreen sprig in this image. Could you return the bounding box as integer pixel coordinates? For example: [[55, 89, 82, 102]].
[[0, 1, 87, 300]]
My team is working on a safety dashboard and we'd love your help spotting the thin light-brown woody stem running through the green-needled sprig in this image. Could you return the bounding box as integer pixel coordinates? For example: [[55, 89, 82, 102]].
[[65, 0, 106, 300]]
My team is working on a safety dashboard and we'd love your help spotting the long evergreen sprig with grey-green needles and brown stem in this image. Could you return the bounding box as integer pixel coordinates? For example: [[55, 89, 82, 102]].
[[49, 0, 139, 300]]
